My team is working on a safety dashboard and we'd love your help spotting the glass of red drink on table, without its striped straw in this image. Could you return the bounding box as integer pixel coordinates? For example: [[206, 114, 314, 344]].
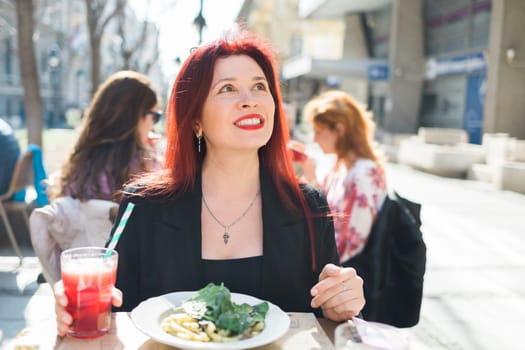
[[60, 247, 118, 339]]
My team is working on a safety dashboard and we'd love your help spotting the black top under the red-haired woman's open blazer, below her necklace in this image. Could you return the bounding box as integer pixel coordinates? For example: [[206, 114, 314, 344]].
[[202, 256, 262, 298]]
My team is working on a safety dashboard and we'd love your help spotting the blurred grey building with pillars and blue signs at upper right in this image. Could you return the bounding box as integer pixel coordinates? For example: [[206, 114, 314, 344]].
[[238, 0, 525, 143]]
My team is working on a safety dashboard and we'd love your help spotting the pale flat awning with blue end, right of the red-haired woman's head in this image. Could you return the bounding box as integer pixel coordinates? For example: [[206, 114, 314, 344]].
[[282, 56, 389, 80]]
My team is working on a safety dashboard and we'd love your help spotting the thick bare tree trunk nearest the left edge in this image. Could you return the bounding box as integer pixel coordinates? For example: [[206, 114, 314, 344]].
[[15, 0, 44, 147]]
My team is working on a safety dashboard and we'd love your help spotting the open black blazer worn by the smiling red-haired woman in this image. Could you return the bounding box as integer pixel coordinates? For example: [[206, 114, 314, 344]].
[[112, 175, 339, 315]]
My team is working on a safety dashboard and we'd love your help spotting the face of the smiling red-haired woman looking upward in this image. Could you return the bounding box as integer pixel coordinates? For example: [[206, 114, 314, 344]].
[[199, 55, 275, 152]]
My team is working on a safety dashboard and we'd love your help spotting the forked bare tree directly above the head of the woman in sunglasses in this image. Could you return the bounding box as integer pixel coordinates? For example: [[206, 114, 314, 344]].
[[85, 0, 126, 96]]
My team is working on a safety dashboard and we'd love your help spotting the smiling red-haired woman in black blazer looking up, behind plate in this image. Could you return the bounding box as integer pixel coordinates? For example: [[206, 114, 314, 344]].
[[57, 31, 364, 334]]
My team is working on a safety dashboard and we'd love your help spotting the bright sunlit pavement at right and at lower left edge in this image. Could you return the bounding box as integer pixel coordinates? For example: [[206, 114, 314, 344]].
[[0, 164, 525, 350]]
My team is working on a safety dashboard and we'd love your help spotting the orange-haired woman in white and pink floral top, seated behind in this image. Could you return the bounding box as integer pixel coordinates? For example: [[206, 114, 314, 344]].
[[290, 91, 387, 263]]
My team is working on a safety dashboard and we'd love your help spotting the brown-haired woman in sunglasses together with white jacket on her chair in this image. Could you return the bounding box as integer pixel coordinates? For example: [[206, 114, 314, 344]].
[[30, 71, 162, 283]]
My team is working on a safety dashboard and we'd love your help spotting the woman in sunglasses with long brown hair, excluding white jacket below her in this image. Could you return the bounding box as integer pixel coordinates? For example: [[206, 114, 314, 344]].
[[55, 71, 162, 200]]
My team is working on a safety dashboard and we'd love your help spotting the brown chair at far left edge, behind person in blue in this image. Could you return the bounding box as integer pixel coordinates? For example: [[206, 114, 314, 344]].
[[0, 151, 33, 264]]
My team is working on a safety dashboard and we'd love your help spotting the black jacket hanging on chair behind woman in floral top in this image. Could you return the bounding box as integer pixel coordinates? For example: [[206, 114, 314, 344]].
[[343, 192, 426, 327]]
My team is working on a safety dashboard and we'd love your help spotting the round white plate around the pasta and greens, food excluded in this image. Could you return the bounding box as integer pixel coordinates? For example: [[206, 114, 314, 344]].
[[131, 292, 290, 350]]
